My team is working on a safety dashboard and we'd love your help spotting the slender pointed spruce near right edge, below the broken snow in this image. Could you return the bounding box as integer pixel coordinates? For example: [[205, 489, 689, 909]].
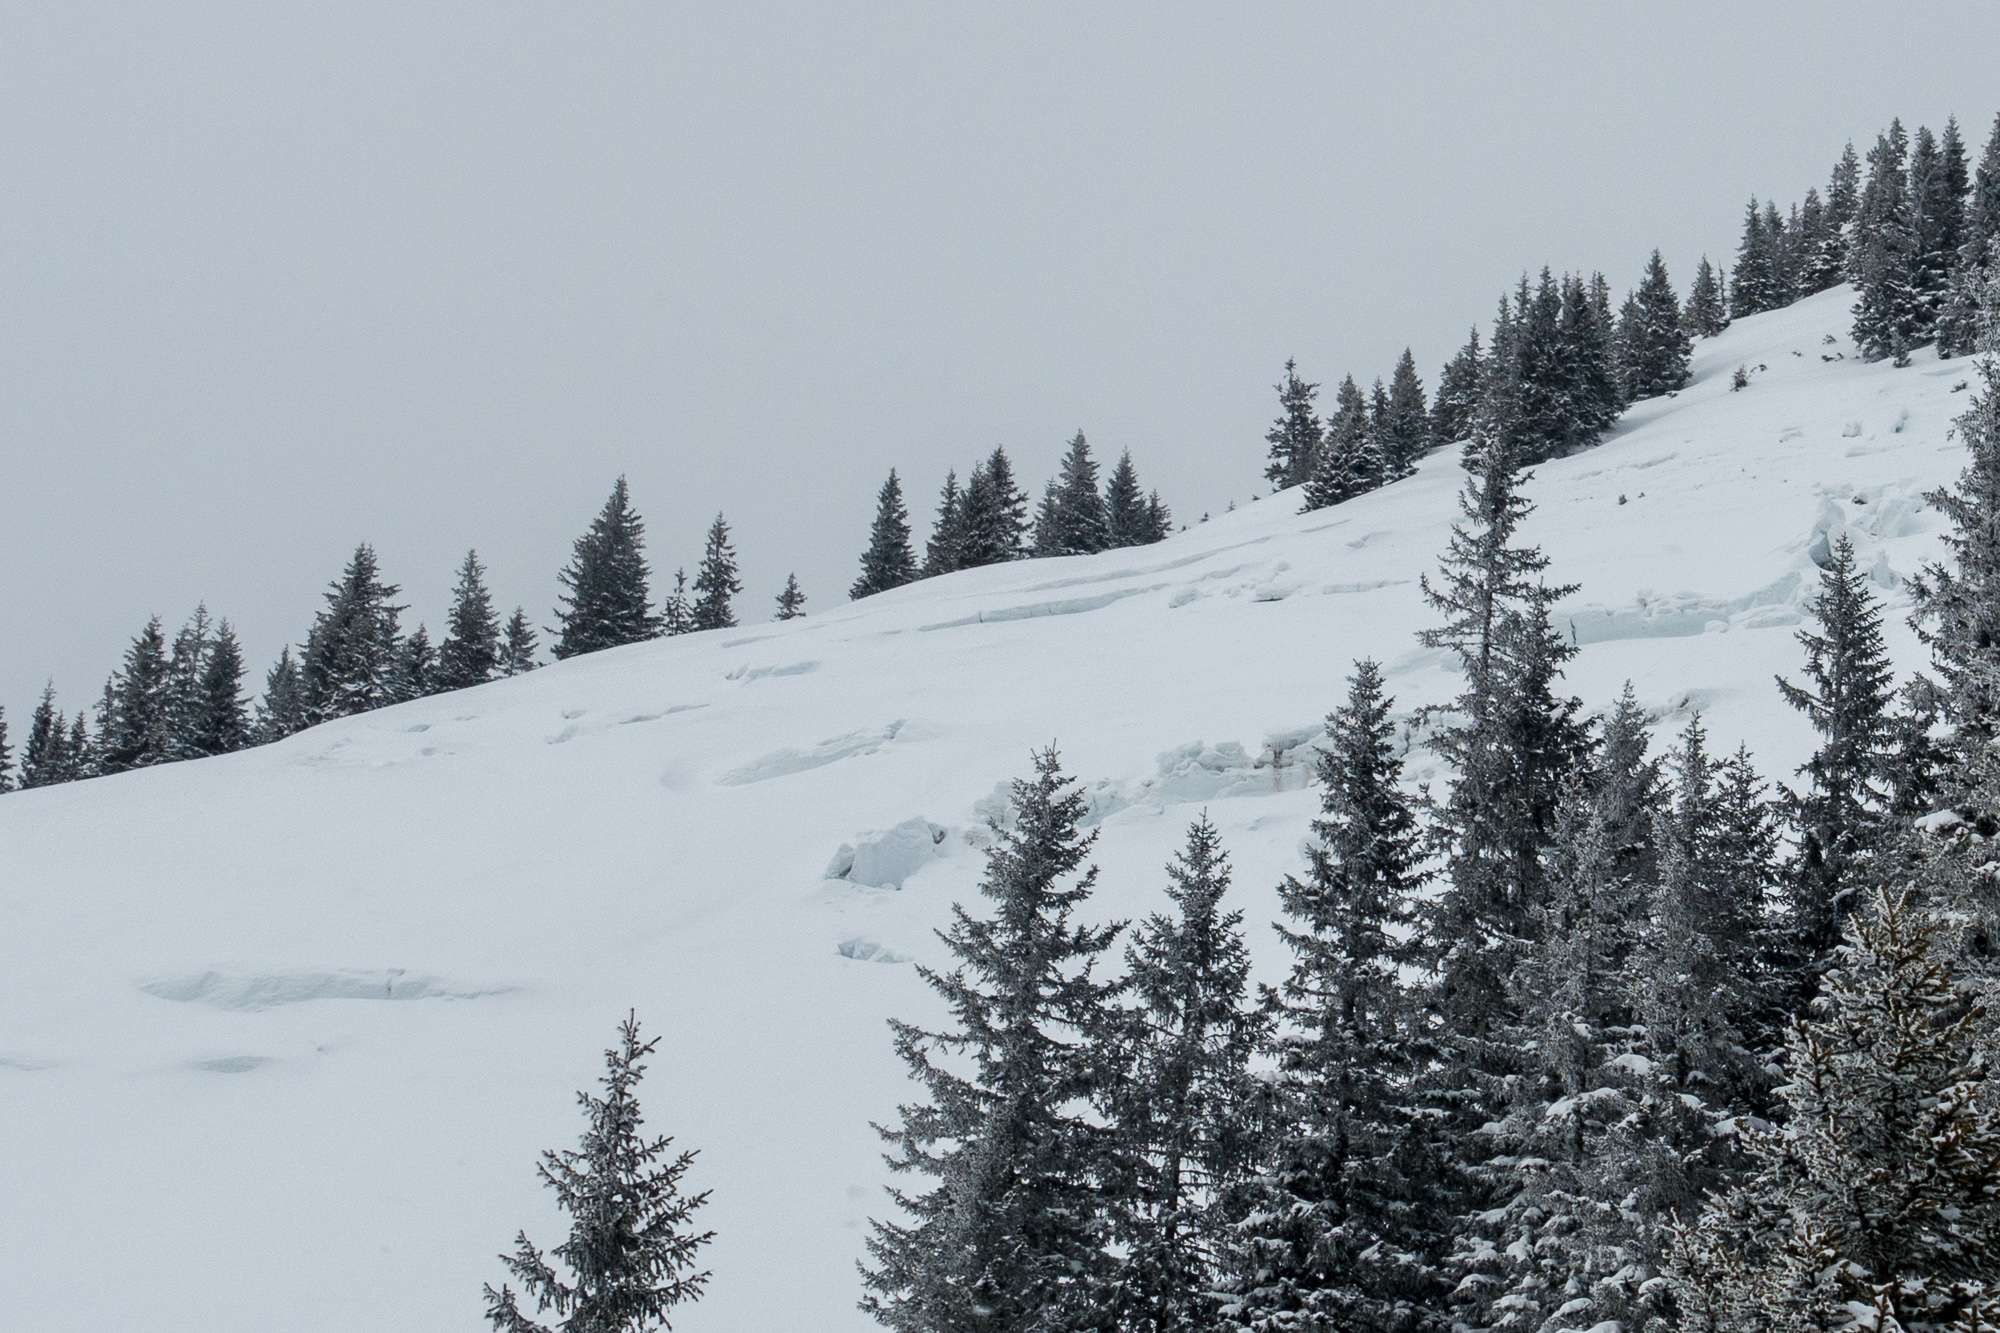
[[1778, 536, 1892, 999]]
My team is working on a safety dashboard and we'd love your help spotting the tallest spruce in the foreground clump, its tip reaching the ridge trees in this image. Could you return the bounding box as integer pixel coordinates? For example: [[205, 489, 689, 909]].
[[1418, 430, 1588, 1047]]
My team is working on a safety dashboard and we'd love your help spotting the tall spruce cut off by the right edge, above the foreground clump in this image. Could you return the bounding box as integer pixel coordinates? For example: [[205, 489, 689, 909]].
[[1910, 360, 2000, 780]]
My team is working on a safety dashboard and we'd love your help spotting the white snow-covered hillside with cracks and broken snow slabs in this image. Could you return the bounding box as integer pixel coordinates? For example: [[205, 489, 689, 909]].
[[0, 288, 1972, 1333]]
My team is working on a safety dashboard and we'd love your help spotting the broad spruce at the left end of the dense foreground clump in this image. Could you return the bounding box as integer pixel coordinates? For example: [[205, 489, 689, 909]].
[[862, 751, 1122, 1333]]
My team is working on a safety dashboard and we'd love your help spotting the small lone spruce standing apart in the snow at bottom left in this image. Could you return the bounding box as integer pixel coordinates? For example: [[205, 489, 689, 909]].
[[486, 1015, 714, 1333]]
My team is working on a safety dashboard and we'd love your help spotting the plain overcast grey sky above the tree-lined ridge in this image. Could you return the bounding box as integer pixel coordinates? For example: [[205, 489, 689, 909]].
[[0, 0, 2000, 716]]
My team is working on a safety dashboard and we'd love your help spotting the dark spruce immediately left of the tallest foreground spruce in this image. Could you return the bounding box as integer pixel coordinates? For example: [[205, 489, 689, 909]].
[[1222, 660, 1448, 1333]]
